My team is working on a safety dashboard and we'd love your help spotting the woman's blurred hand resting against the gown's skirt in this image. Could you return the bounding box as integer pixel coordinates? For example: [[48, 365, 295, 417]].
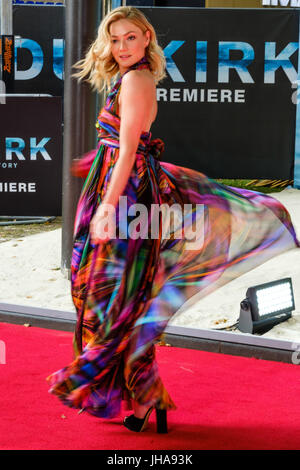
[[90, 203, 116, 244]]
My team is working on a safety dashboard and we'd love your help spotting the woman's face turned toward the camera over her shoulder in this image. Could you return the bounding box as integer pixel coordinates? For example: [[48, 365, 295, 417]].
[[109, 19, 150, 75]]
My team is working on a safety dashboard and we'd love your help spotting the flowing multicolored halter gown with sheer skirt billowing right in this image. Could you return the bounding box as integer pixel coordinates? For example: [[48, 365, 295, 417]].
[[48, 57, 300, 418]]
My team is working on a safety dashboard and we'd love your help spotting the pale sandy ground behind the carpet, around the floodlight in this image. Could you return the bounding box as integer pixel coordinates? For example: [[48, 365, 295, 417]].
[[0, 189, 300, 342]]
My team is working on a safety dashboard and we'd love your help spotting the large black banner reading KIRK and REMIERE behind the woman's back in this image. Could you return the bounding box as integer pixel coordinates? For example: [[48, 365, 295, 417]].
[[141, 7, 299, 179]]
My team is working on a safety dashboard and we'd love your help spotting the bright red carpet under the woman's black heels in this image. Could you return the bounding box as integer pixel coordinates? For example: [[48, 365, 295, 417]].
[[0, 323, 300, 450]]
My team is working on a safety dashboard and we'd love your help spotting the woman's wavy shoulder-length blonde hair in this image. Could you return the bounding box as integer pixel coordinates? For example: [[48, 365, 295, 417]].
[[72, 6, 166, 92]]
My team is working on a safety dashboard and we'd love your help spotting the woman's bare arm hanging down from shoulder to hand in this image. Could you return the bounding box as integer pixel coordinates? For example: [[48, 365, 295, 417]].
[[90, 70, 153, 243]]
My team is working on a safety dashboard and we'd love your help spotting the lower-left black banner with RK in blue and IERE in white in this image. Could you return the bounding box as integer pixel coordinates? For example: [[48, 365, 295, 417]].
[[0, 97, 63, 216]]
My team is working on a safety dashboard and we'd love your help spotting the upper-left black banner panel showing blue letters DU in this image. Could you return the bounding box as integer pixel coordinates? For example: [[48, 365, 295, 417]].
[[13, 5, 65, 96]]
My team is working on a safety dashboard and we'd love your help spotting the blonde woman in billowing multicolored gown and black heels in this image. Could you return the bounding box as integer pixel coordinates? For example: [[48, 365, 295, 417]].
[[49, 7, 299, 432]]
